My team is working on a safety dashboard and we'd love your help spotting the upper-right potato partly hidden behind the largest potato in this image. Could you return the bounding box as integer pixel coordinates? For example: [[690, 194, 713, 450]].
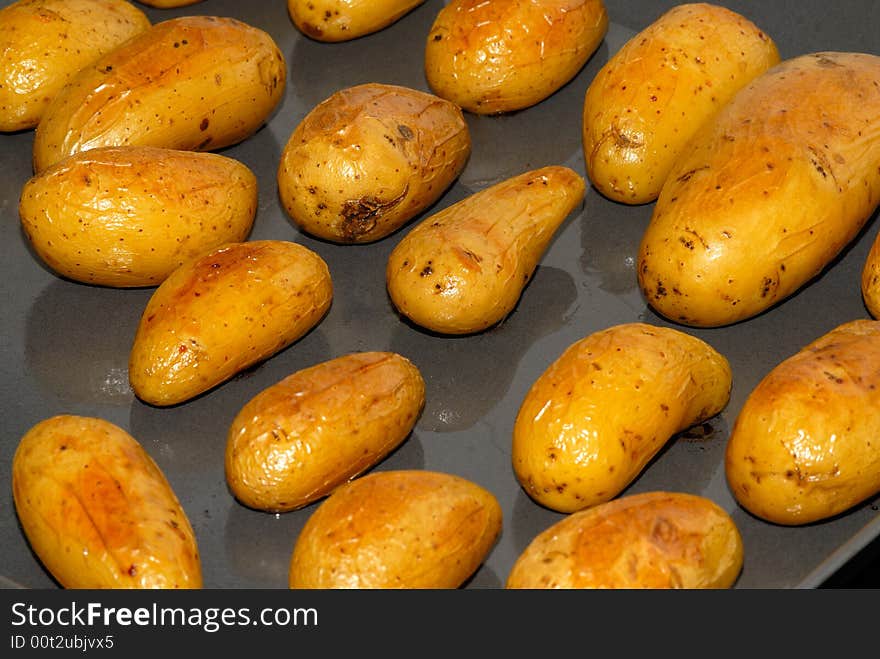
[[583, 3, 779, 204]]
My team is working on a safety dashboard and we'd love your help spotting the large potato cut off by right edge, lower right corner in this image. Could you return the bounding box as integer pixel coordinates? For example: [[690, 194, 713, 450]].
[[725, 320, 880, 526]]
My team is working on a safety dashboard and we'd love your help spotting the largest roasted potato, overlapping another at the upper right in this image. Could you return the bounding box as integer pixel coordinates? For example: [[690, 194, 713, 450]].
[[637, 52, 880, 327]]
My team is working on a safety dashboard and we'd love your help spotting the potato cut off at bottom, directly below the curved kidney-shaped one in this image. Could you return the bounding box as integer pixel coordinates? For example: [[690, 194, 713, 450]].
[[506, 492, 743, 589]]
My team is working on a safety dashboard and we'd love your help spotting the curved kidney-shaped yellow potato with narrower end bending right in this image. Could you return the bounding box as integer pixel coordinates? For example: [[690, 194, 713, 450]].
[[512, 323, 732, 513]]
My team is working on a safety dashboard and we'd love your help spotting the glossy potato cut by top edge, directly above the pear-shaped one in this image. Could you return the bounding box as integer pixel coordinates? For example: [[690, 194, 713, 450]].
[[425, 0, 608, 114]]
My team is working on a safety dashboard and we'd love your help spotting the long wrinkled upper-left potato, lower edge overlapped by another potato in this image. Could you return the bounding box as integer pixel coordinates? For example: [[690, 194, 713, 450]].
[[34, 16, 287, 172]]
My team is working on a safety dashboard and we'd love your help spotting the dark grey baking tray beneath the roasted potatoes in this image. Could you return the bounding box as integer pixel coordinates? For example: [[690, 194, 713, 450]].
[[0, 0, 880, 588]]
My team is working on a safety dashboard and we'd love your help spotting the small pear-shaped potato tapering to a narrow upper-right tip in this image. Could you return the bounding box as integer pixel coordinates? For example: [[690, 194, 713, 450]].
[[386, 166, 585, 334]]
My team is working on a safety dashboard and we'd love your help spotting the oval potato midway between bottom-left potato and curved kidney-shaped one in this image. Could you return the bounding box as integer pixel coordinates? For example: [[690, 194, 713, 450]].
[[226, 352, 425, 512]]
